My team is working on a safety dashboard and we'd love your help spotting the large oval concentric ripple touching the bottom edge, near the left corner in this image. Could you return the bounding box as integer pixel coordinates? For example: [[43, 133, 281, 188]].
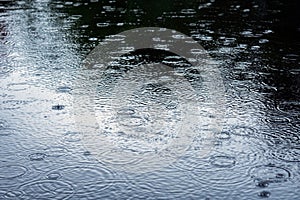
[[20, 180, 74, 200]]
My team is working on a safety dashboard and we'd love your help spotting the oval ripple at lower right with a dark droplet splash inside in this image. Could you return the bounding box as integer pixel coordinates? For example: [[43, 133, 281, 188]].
[[250, 165, 291, 183]]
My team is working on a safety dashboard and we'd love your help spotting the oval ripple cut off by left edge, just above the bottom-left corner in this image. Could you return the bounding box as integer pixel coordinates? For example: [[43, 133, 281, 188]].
[[0, 165, 27, 179]]
